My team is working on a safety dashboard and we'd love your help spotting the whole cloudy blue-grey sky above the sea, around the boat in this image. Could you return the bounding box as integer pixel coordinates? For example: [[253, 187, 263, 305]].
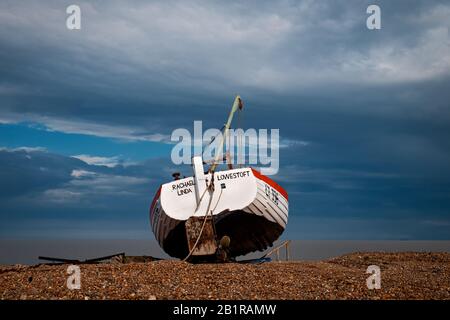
[[0, 0, 450, 240]]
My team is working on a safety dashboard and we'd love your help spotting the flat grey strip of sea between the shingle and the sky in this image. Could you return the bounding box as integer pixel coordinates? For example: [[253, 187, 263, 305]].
[[0, 239, 450, 265]]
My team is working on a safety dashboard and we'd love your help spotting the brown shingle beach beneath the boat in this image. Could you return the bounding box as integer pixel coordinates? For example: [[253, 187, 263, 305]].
[[0, 253, 450, 300]]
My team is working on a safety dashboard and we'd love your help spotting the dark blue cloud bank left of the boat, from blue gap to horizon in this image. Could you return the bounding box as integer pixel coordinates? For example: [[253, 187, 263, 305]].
[[0, 149, 175, 237]]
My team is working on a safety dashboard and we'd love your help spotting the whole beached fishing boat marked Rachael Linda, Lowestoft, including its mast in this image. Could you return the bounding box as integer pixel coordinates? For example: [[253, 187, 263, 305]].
[[150, 96, 289, 261]]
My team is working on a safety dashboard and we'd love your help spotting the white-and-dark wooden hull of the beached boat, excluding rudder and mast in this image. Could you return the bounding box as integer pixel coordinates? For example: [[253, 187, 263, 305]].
[[150, 168, 289, 258]]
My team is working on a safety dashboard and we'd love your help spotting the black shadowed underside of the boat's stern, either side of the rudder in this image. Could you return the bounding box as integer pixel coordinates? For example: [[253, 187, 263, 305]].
[[163, 211, 284, 259]]
